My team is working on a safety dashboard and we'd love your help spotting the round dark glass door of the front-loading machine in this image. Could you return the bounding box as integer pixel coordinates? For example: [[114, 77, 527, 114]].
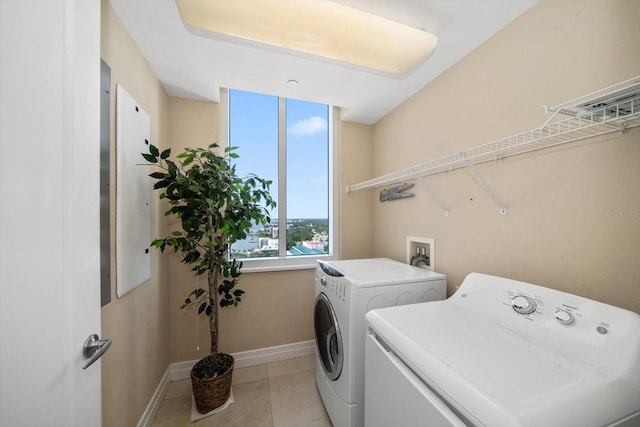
[[314, 293, 344, 381]]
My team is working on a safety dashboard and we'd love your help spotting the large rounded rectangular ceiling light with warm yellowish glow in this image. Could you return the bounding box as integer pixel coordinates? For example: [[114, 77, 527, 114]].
[[176, 0, 437, 74]]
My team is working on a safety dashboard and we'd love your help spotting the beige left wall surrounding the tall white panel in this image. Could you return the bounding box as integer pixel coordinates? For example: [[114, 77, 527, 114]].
[[101, 1, 169, 427]]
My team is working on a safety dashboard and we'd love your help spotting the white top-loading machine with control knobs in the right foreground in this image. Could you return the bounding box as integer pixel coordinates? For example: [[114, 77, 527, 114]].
[[365, 273, 640, 427]]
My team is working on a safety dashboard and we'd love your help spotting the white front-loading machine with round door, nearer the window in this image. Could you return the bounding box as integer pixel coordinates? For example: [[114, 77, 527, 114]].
[[314, 258, 447, 427]]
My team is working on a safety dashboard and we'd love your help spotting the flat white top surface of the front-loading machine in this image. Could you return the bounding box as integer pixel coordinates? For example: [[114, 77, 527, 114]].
[[324, 258, 445, 287]]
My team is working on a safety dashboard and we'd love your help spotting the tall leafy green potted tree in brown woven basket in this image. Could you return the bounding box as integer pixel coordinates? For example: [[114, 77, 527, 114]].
[[142, 144, 276, 413]]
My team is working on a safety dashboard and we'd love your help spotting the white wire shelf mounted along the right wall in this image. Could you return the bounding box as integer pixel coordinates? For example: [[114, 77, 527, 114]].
[[346, 77, 640, 192]]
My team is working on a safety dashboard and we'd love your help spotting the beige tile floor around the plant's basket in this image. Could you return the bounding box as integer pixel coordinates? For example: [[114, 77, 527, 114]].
[[151, 355, 331, 427]]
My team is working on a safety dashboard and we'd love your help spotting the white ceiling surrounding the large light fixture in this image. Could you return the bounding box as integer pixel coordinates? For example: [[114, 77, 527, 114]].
[[109, 0, 538, 124]]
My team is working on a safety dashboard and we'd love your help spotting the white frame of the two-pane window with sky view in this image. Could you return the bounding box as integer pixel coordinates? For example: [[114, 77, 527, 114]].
[[220, 88, 340, 273]]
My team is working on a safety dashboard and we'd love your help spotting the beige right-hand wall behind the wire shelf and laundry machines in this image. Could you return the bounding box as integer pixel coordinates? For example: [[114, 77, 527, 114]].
[[369, 0, 640, 312]]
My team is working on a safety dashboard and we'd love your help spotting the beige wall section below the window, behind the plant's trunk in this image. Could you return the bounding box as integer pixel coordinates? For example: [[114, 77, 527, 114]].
[[171, 266, 314, 362]]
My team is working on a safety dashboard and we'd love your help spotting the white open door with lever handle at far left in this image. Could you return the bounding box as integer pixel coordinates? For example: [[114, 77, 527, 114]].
[[0, 0, 101, 427]]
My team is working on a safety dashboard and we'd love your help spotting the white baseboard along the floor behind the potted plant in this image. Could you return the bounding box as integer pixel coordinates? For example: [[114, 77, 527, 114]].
[[138, 340, 316, 427]]
